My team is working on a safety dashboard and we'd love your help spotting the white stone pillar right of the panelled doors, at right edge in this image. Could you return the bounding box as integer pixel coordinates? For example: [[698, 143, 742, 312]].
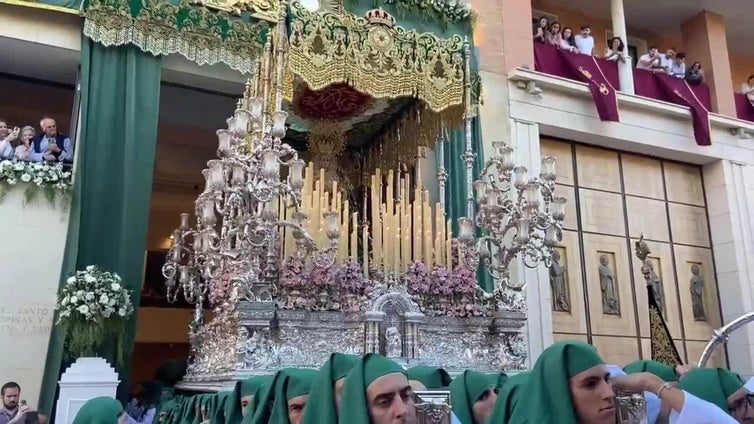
[[704, 161, 754, 376]]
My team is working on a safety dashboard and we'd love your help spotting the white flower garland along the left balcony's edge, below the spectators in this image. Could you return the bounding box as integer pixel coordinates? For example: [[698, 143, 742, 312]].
[[0, 160, 73, 206]]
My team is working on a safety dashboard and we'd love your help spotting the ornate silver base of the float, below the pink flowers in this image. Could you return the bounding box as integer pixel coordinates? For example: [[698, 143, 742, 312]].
[[178, 291, 528, 390]]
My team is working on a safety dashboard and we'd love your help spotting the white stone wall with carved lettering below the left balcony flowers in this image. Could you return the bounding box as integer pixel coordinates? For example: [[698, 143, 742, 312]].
[[0, 184, 68, 407]]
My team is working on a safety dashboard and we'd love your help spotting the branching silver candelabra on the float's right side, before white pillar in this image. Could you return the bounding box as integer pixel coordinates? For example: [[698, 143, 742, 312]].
[[458, 142, 566, 291]]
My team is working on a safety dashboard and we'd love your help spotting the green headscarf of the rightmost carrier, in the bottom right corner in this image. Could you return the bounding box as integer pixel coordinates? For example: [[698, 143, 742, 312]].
[[678, 368, 744, 412]]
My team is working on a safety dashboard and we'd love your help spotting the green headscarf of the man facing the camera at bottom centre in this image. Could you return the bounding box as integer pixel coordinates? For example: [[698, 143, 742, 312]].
[[338, 353, 408, 424]]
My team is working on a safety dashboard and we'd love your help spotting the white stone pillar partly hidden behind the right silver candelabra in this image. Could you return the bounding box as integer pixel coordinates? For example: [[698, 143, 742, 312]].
[[510, 119, 553, 364]]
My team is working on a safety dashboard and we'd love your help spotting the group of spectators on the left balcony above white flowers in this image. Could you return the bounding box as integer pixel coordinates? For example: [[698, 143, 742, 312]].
[[0, 116, 73, 163]]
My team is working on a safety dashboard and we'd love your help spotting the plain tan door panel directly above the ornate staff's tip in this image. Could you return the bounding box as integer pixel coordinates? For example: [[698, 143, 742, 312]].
[[626, 196, 670, 242]]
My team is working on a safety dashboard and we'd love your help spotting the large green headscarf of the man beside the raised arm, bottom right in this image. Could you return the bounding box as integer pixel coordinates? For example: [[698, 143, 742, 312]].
[[511, 341, 604, 424]]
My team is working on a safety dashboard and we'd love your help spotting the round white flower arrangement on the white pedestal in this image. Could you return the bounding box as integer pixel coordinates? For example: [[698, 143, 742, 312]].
[[55, 265, 134, 362]]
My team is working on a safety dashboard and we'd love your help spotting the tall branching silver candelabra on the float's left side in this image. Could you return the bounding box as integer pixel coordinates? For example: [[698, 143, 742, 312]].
[[162, 85, 339, 308]]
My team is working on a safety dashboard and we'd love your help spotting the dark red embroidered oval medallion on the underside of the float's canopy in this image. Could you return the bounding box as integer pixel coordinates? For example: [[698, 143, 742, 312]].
[[294, 83, 373, 120]]
